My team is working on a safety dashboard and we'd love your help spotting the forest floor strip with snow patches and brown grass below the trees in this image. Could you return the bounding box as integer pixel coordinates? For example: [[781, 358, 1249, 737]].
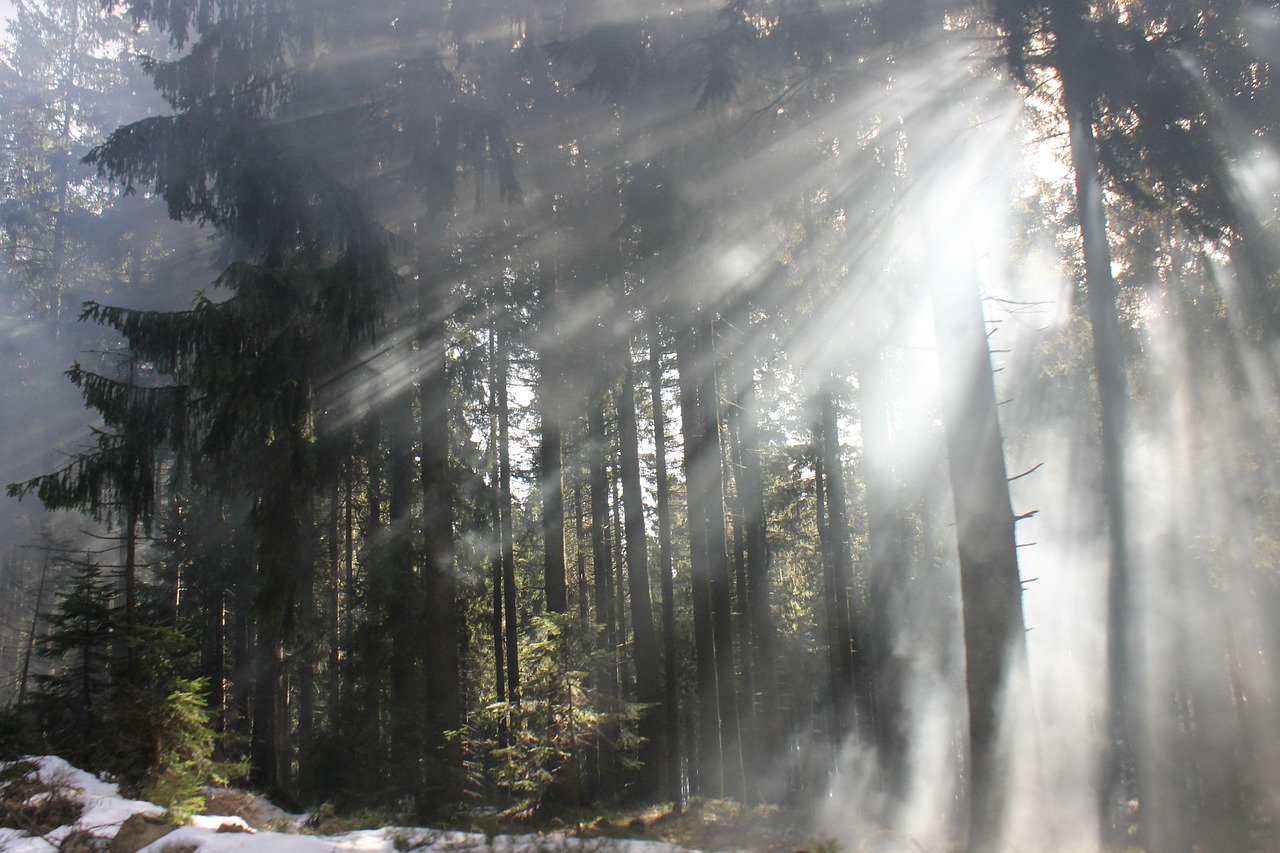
[[0, 756, 832, 853]]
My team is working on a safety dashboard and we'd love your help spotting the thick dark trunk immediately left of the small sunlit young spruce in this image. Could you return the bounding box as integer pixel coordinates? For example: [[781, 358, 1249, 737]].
[[419, 263, 462, 807]]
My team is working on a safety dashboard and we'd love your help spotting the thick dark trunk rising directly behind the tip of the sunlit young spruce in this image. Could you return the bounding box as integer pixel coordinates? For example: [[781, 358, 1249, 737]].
[[538, 272, 568, 613]]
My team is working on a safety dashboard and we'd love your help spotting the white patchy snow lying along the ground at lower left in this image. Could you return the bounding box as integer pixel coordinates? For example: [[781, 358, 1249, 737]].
[[0, 756, 706, 853]]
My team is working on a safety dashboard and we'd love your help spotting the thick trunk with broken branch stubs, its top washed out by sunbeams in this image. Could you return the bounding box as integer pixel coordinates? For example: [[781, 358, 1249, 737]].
[[932, 245, 1028, 853]]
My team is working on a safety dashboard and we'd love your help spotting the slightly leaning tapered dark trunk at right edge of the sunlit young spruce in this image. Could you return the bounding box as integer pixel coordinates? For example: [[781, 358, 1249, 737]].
[[618, 341, 666, 795]]
